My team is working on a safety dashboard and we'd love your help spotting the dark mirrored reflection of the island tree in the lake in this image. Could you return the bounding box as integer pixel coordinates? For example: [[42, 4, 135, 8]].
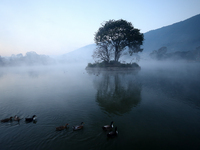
[[86, 71, 141, 115]]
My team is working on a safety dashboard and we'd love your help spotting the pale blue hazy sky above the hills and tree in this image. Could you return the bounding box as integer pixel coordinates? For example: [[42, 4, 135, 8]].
[[0, 0, 200, 56]]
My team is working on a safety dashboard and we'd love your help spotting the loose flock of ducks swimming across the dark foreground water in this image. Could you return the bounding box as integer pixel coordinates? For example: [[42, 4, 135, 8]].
[[1, 115, 118, 137]]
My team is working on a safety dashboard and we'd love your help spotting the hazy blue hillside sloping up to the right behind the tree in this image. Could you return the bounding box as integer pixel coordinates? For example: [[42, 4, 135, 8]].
[[143, 14, 200, 53]]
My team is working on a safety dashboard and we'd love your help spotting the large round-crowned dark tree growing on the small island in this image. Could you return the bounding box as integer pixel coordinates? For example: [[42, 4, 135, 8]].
[[93, 19, 144, 62]]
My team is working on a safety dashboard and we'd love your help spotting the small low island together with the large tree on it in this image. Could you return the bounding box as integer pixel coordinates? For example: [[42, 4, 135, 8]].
[[86, 19, 144, 70]]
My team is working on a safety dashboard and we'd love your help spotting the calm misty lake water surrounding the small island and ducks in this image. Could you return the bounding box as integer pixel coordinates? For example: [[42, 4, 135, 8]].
[[0, 62, 200, 150]]
